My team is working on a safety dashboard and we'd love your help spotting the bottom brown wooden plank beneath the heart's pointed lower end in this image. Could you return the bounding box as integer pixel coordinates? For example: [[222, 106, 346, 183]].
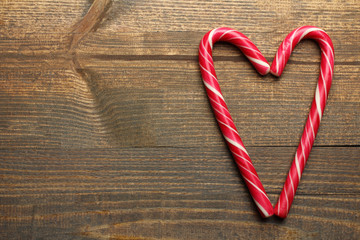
[[0, 147, 360, 239]]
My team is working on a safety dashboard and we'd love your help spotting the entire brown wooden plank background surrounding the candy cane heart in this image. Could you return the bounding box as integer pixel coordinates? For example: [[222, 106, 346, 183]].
[[0, 0, 360, 239]]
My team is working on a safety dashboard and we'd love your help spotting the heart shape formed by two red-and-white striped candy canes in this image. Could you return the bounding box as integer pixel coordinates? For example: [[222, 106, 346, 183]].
[[199, 26, 334, 218]]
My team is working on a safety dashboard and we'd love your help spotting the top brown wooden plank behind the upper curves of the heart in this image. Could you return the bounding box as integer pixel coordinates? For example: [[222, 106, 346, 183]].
[[0, 0, 360, 57]]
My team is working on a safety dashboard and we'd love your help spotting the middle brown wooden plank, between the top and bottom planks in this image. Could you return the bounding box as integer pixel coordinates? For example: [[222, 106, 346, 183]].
[[0, 58, 360, 148]]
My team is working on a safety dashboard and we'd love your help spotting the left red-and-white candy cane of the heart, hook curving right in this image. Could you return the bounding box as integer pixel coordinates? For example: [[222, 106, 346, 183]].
[[199, 28, 274, 217]]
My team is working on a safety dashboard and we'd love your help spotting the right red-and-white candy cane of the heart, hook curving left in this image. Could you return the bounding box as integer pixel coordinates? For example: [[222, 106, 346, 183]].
[[270, 26, 334, 218]]
